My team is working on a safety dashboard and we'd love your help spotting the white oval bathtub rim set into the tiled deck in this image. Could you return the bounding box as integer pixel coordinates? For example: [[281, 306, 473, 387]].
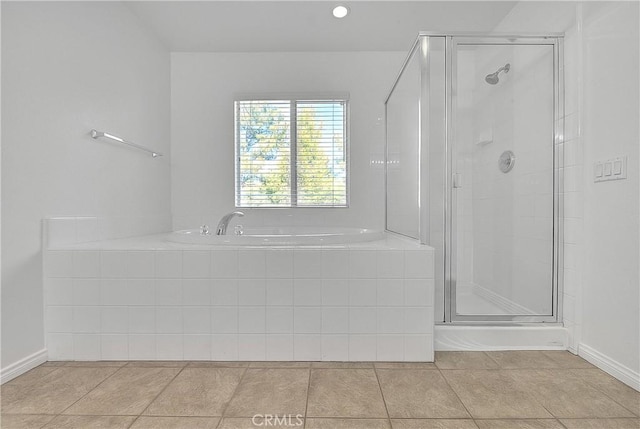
[[167, 226, 384, 246]]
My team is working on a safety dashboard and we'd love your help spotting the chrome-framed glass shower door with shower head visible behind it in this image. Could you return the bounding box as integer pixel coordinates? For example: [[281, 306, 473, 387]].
[[448, 38, 558, 321]]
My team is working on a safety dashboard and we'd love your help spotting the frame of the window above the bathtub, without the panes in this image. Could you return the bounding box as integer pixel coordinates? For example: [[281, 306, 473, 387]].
[[233, 93, 351, 209]]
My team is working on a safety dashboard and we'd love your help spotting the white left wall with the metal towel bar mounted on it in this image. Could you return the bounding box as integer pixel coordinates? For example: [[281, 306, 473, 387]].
[[2, 2, 170, 370]]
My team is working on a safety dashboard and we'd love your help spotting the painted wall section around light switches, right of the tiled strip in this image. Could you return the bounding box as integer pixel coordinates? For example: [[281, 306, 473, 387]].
[[581, 2, 640, 382]]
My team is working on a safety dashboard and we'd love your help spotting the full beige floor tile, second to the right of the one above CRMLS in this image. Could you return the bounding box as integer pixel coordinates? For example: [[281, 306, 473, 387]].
[[378, 369, 470, 419]]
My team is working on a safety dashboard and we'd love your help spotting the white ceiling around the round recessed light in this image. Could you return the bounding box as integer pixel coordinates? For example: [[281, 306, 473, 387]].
[[125, 0, 516, 52]]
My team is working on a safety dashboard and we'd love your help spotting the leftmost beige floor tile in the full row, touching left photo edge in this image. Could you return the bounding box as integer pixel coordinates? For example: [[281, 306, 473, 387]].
[[2, 367, 118, 414]]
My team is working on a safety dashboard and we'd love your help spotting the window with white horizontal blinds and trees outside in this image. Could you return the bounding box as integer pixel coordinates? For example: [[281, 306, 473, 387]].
[[235, 99, 348, 207]]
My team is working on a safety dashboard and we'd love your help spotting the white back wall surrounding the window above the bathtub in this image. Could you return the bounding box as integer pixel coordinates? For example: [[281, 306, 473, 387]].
[[171, 52, 406, 229]]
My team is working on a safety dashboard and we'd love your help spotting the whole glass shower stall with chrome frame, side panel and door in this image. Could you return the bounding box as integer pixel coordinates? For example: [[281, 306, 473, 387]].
[[385, 33, 564, 326]]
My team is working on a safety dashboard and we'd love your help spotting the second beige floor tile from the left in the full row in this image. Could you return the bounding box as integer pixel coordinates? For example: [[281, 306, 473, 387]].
[[64, 367, 180, 415]]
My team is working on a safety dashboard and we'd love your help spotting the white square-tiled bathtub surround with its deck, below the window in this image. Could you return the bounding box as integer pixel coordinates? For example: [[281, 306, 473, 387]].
[[44, 235, 434, 361]]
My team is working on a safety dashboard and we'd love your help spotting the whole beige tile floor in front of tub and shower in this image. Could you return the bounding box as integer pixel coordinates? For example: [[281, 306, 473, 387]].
[[0, 351, 640, 429]]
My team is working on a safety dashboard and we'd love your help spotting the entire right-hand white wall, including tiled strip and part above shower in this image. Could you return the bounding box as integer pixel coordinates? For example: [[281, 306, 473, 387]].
[[496, 1, 640, 388]]
